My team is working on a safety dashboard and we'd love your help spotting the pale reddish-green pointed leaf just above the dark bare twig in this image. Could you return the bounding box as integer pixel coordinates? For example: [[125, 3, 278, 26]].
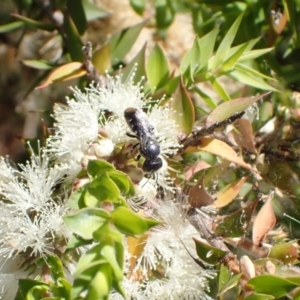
[[206, 92, 270, 126]]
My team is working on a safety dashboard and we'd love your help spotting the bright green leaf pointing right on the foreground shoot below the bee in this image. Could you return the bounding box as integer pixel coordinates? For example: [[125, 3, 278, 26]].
[[111, 207, 161, 235]]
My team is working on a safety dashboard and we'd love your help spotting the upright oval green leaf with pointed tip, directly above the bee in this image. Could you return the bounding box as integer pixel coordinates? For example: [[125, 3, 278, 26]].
[[146, 45, 169, 93]]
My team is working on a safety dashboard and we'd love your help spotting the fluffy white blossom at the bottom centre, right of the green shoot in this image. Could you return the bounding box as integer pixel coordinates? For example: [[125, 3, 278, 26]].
[[112, 201, 215, 300]]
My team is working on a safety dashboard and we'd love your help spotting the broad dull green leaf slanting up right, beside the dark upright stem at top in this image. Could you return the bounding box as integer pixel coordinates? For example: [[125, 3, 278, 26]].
[[107, 22, 146, 64]]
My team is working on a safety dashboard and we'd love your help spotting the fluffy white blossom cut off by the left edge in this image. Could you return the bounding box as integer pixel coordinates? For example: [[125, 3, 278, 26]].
[[0, 146, 71, 300]]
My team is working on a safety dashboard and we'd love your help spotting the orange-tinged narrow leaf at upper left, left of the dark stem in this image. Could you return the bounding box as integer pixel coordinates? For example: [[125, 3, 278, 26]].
[[36, 62, 86, 89]]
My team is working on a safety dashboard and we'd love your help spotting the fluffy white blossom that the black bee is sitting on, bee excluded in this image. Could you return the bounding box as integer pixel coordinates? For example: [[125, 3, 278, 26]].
[[46, 70, 180, 190]]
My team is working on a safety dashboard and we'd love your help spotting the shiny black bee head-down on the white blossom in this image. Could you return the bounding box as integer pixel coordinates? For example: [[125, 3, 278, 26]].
[[124, 107, 163, 173]]
